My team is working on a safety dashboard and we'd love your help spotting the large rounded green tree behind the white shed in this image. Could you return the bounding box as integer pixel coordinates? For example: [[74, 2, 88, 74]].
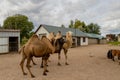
[[3, 14, 34, 39]]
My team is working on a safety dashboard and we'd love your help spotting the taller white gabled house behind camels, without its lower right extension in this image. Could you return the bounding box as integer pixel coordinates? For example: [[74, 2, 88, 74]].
[[35, 25, 88, 46]]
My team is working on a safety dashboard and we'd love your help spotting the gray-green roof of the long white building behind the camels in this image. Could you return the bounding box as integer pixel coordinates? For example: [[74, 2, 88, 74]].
[[35, 24, 102, 39]]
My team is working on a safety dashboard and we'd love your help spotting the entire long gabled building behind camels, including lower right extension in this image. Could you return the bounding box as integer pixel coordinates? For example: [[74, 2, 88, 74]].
[[35, 24, 103, 47]]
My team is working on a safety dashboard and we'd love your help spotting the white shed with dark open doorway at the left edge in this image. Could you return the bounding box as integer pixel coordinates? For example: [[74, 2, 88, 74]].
[[0, 29, 20, 53]]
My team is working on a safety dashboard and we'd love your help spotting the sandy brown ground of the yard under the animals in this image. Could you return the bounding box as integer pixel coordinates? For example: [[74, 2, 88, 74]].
[[0, 45, 120, 80]]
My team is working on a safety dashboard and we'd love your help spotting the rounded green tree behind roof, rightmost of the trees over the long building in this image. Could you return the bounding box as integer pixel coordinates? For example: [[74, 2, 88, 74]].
[[85, 23, 101, 34]]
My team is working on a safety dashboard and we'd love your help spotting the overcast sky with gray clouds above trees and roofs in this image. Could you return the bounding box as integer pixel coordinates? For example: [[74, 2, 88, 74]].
[[0, 0, 120, 35]]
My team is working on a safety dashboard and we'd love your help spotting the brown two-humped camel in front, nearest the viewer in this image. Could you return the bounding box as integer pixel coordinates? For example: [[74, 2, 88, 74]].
[[20, 34, 55, 77]]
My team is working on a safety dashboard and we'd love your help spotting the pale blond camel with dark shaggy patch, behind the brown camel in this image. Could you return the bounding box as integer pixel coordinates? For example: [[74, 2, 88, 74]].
[[41, 31, 73, 68]]
